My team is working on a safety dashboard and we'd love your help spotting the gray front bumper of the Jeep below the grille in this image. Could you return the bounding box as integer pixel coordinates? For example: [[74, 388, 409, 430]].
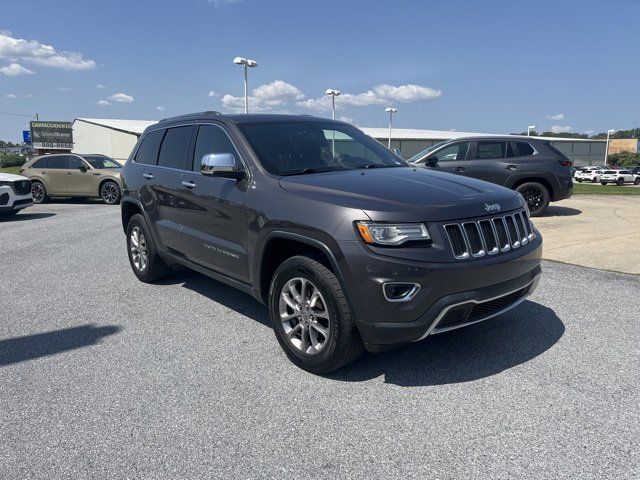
[[341, 233, 542, 352]]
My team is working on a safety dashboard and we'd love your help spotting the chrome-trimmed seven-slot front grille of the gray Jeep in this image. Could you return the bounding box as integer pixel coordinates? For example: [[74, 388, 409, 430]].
[[444, 210, 535, 260]]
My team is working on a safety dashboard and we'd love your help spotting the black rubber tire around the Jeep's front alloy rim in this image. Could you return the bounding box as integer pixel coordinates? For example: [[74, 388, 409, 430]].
[[269, 255, 364, 374]]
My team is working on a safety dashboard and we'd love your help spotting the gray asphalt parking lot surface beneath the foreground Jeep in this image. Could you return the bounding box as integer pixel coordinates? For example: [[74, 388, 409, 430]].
[[0, 202, 640, 479]]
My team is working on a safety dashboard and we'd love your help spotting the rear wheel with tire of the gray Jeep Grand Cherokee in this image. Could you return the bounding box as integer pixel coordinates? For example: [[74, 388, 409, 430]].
[[127, 213, 169, 283]]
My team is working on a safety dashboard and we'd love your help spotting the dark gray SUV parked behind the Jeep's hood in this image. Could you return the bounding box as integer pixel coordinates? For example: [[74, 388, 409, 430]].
[[409, 136, 573, 216]]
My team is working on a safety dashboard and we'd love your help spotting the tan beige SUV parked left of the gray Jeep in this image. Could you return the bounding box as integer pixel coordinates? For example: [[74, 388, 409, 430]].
[[20, 153, 122, 205]]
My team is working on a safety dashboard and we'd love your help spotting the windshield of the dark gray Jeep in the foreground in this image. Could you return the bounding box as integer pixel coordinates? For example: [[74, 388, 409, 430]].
[[238, 121, 407, 175]]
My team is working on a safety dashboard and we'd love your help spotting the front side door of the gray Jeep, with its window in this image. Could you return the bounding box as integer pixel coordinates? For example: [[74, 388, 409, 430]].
[[180, 125, 249, 282]]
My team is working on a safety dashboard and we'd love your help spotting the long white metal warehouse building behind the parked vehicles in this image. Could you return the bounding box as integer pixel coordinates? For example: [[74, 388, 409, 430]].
[[73, 118, 606, 166]]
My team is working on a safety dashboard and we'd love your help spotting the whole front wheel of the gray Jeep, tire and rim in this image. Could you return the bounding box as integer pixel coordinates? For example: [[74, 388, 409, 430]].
[[269, 256, 363, 373]]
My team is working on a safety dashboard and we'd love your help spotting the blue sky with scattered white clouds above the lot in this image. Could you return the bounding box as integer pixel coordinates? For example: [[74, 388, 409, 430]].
[[0, 0, 640, 141]]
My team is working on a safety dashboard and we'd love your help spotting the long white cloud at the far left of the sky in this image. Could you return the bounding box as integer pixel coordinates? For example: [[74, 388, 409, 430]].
[[0, 32, 96, 70]]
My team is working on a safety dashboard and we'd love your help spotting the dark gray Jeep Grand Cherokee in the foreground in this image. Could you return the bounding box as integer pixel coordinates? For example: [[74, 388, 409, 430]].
[[122, 112, 542, 373]]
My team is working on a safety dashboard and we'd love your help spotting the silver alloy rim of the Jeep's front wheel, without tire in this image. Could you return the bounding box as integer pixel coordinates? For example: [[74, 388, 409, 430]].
[[279, 277, 331, 355]]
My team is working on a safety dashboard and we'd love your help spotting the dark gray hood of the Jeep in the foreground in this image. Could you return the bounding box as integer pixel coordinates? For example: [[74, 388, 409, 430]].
[[280, 168, 524, 221]]
